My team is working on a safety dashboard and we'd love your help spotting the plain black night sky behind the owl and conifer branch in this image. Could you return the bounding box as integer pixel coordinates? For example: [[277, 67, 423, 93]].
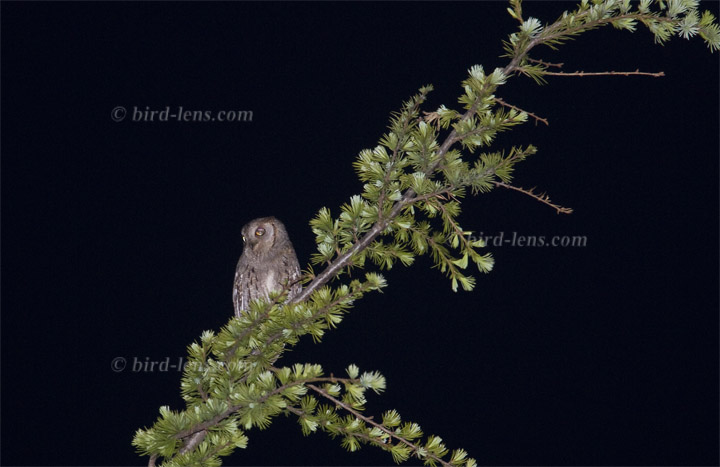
[[0, 2, 720, 465]]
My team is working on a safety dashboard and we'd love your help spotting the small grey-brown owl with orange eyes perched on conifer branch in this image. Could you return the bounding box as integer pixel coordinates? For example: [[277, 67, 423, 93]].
[[233, 217, 302, 316]]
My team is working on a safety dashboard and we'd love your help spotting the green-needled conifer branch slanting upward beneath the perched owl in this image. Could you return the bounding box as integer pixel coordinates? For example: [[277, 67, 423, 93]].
[[133, 0, 720, 466]]
